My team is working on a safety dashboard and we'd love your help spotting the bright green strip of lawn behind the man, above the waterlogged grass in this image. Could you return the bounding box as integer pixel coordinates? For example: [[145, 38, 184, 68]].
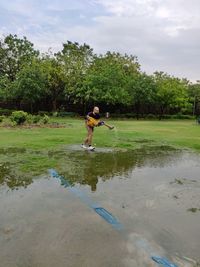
[[0, 119, 200, 151]]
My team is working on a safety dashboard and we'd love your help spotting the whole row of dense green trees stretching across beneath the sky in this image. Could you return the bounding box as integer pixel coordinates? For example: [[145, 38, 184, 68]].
[[0, 35, 200, 118]]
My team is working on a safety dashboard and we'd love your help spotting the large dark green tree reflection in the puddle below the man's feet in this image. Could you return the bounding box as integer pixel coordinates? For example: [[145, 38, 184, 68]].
[[62, 147, 181, 191]]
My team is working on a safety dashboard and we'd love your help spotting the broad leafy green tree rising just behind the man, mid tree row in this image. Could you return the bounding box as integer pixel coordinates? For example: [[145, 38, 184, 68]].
[[84, 52, 139, 105]]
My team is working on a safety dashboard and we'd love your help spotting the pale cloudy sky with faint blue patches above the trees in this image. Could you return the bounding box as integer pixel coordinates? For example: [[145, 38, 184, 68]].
[[0, 0, 200, 82]]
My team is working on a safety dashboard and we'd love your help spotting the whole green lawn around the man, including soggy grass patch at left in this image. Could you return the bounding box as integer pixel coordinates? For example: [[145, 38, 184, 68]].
[[0, 118, 200, 184]]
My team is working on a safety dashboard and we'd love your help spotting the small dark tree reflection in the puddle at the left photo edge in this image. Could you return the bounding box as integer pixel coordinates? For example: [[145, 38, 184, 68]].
[[0, 162, 32, 189]]
